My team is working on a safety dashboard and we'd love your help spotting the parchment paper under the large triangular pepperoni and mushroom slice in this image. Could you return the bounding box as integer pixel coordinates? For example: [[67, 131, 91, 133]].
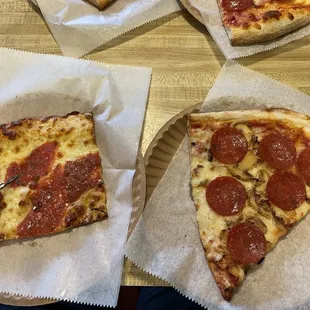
[[126, 61, 310, 310]]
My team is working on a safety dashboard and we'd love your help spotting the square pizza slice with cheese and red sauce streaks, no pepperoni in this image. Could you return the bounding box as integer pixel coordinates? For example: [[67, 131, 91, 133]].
[[0, 112, 107, 240]]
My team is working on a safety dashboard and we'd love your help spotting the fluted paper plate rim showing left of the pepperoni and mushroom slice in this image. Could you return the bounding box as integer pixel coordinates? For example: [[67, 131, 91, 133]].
[[144, 103, 202, 202]]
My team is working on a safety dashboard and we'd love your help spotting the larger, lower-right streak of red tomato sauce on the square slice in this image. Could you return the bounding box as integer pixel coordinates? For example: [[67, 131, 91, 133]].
[[17, 153, 102, 237]]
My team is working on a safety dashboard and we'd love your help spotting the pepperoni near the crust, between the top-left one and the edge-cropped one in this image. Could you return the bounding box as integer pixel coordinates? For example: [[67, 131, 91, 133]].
[[258, 133, 296, 170]]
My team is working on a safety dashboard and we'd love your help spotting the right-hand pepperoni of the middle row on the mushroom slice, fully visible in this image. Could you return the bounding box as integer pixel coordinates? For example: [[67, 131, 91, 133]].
[[267, 171, 306, 211]]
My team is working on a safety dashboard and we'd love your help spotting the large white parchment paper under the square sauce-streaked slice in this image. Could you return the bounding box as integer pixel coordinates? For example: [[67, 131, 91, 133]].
[[0, 49, 151, 306]]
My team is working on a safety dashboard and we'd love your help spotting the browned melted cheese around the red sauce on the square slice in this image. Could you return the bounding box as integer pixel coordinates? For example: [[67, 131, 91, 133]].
[[0, 114, 106, 239]]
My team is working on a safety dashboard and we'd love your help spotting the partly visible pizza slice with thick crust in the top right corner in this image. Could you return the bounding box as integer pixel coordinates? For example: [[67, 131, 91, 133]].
[[217, 0, 310, 45]]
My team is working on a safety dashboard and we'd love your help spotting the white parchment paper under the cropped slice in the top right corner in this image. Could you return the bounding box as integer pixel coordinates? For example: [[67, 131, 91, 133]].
[[189, 0, 310, 59]]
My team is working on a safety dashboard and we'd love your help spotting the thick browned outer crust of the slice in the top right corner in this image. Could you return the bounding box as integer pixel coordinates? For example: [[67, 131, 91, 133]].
[[226, 11, 310, 46]]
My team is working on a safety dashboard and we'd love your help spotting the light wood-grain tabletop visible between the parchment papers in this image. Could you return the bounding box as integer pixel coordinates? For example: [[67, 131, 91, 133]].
[[0, 0, 310, 286]]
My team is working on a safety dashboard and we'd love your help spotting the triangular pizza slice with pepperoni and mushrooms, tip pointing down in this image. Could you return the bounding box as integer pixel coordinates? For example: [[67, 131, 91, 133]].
[[188, 109, 310, 300]]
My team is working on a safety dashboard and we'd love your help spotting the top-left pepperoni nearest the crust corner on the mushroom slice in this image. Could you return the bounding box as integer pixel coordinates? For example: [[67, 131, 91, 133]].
[[211, 126, 248, 164]]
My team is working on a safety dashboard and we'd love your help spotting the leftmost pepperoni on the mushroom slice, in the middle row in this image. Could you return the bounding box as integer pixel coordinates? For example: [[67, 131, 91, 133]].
[[206, 177, 247, 216]]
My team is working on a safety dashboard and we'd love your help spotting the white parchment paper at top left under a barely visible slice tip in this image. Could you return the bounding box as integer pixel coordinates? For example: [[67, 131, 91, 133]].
[[36, 0, 181, 57]]
